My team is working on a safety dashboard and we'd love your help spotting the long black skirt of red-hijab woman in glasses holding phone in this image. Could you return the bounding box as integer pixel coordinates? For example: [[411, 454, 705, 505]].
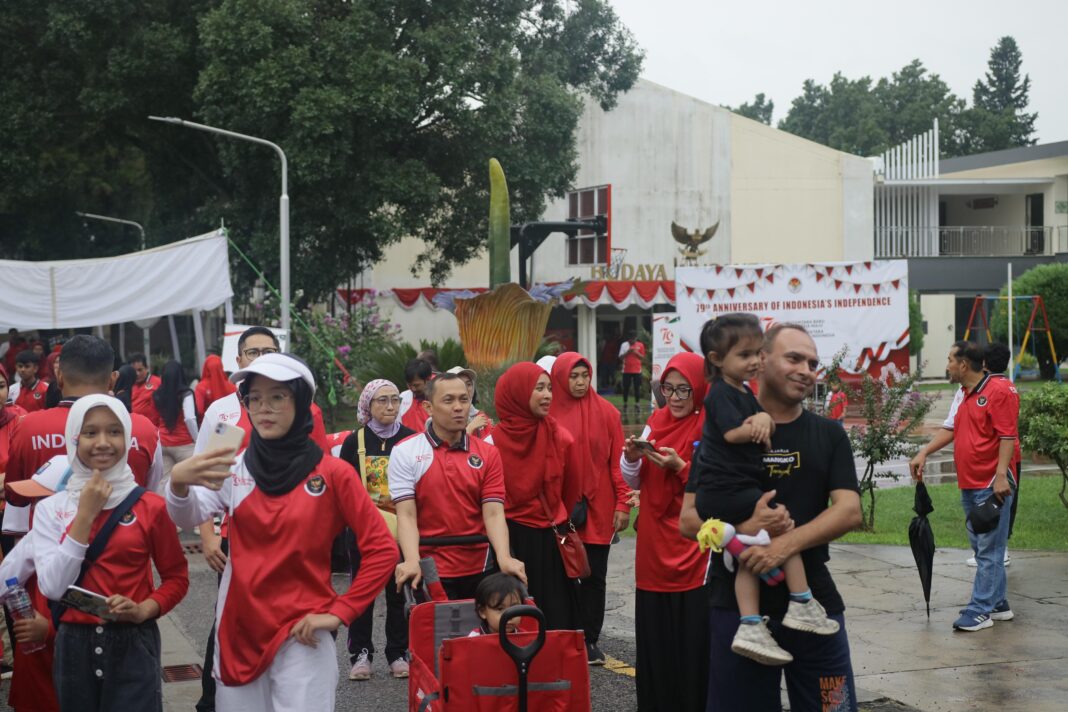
[[634, 587, 709, 712]]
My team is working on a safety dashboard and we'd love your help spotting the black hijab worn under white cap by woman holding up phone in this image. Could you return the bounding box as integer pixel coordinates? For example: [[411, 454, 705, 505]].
[[240, 376, 323, 496]]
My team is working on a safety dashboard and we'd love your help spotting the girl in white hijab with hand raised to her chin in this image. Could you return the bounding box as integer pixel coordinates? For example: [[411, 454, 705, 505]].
[[29, 395, 189, 712]]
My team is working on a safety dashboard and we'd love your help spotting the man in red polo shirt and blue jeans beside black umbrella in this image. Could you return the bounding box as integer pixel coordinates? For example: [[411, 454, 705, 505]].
[[911, 342, 1020, 632]]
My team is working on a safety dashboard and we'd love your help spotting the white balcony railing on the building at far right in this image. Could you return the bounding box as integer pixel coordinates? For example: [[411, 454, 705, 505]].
[[875, 225, 1068, 257]]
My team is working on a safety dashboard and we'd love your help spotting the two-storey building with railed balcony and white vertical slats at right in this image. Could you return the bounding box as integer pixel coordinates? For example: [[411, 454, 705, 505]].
[[875, 123, 1068, 376]]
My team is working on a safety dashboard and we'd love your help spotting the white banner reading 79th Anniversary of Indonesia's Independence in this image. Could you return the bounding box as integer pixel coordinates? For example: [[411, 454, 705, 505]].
[[675, 259, 909, 377]]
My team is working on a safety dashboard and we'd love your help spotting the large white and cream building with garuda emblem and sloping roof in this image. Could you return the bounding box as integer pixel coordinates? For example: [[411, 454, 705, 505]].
[[354, 80, 874, 377]]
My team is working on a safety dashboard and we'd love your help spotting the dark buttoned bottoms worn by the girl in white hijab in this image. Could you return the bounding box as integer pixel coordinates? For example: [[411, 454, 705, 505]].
[[52, 620, 163, 712]]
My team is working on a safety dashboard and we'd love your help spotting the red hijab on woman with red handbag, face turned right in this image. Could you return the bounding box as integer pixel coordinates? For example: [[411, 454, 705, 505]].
[[493, 361, 564, 504]]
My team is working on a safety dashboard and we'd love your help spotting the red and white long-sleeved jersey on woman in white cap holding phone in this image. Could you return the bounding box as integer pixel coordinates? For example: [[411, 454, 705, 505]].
[[167, 455, 397, 685]]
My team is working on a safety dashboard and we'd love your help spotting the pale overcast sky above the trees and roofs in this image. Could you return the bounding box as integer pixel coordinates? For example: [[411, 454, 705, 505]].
[[609, 0, 1068, 143]]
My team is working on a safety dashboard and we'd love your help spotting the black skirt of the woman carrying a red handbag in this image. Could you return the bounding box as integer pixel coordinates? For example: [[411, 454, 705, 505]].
[[508, 520, 581, 631]]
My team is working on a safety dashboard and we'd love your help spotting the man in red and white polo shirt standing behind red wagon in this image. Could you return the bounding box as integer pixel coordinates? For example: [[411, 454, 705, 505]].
[[388, 374, 527, 599]]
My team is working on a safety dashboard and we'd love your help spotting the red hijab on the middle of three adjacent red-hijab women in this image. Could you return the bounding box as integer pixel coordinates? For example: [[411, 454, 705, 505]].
[[549, 351, 619, 476]]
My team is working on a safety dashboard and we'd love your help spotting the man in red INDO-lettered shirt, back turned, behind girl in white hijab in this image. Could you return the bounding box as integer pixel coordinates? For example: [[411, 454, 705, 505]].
[[3, 334, 163, 534]]
